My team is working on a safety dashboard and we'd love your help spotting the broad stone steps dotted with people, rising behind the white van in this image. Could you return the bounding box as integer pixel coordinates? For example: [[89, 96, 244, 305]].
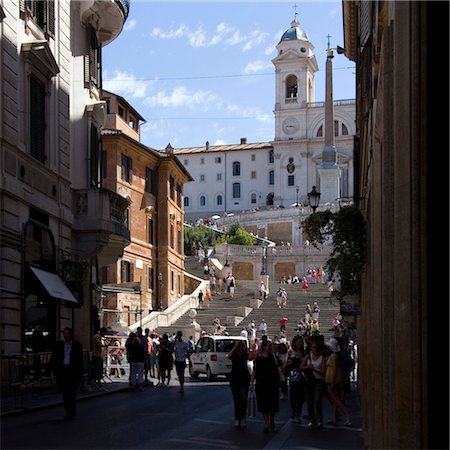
[[155, 257, 339, 340]]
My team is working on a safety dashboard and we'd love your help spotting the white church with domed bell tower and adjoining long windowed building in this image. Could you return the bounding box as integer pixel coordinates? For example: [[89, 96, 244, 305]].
[[171, 19, 355, 221]]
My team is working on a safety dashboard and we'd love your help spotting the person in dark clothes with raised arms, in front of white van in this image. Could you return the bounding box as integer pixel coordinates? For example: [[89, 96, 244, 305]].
[[227, 340, 252, 427]]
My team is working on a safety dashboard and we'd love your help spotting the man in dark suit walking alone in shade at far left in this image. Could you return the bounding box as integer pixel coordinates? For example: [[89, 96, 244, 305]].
[[52, 327, 83, 420]]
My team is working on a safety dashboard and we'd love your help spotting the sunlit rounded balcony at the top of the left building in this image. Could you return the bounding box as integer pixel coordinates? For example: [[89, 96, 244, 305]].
[[80, 0, 130, 45]]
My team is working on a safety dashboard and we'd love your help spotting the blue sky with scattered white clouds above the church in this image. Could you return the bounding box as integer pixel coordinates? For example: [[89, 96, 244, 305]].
[[102, 0, 355, 150]]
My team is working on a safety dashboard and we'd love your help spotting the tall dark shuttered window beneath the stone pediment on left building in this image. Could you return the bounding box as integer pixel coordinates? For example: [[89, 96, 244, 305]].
[[30, 76, 47, 163]]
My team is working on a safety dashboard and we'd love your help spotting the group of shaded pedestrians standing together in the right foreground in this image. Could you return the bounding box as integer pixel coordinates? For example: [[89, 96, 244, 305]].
[[228, 334, 355, 433]]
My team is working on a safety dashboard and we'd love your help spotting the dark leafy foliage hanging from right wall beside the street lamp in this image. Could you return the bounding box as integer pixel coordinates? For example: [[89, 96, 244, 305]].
[[302, 205, 366, 293]]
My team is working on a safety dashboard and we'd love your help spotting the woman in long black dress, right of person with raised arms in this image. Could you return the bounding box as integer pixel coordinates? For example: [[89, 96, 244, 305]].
[[251, 341, 280, 433]]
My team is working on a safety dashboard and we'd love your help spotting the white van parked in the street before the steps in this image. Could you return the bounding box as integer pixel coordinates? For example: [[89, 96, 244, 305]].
[[189, 336, 253, 380]]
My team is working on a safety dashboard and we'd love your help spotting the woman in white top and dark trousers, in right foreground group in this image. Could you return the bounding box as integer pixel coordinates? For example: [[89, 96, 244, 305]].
[[301, 341, 326, 428]]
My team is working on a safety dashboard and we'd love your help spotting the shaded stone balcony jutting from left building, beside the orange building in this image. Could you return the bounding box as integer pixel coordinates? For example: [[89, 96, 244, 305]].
[[73, 189, 130, 265]]
